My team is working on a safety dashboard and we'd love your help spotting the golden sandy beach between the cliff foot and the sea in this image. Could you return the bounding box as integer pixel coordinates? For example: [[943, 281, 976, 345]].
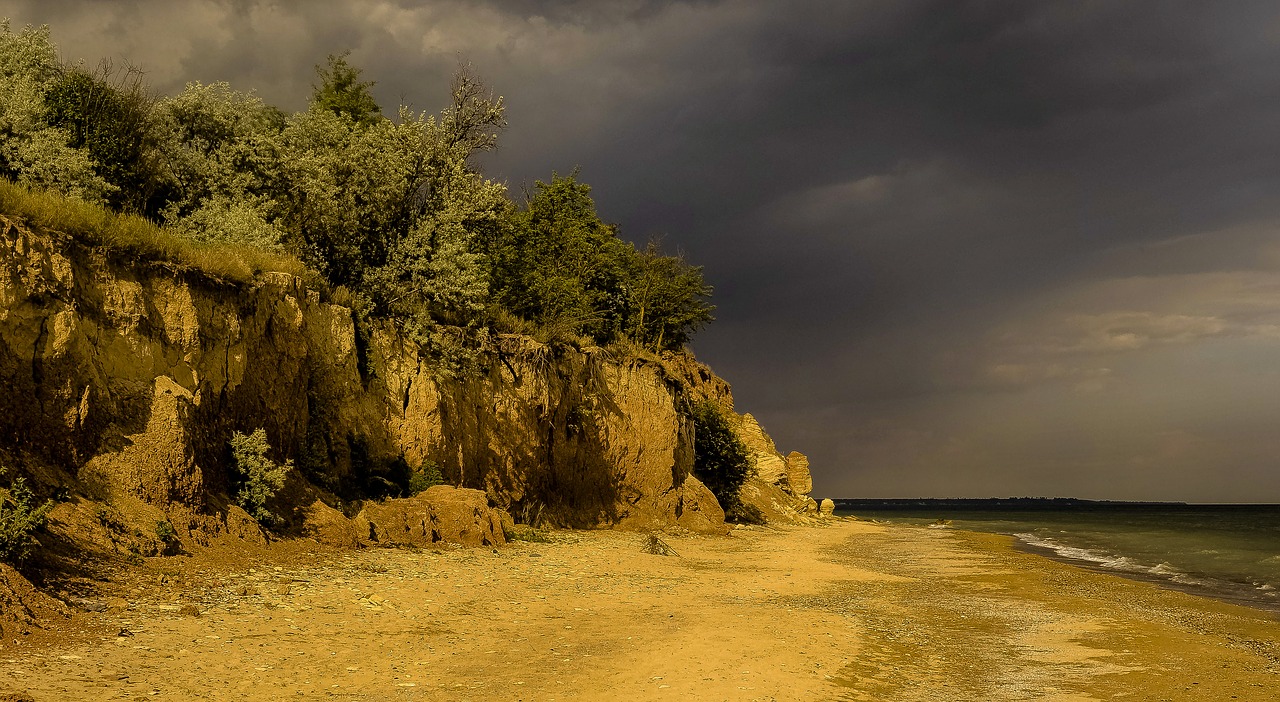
[[0, 521, 1280, 702]]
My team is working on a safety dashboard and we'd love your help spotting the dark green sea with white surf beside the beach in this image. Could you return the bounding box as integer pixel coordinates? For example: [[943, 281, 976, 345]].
[[836, 498, 1280, 612]]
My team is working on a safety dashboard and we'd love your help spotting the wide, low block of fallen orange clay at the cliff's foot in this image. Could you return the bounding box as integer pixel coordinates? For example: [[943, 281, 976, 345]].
[[352, 486, 507, 546]]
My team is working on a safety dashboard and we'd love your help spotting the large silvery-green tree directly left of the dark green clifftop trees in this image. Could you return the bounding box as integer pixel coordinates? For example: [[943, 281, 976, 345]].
[[283, 101, 507, 332]]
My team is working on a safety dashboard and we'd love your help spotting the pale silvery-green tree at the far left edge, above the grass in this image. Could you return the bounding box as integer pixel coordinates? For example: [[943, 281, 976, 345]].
[[0, 19, 115, 202]]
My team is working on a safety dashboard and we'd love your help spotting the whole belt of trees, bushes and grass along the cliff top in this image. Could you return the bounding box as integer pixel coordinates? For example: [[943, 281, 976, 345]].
[[0, 20, 713, 356]]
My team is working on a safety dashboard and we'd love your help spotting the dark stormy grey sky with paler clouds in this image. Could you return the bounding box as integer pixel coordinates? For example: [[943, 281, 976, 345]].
[[10, 0, 1280, 502]]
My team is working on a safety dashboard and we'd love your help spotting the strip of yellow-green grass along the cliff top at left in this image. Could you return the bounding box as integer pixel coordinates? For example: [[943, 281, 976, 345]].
[[0, 178, 320, 286]]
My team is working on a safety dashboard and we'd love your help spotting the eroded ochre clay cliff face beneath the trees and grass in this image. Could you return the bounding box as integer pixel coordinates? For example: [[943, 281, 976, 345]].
[[0, 218, 768, 542]]
